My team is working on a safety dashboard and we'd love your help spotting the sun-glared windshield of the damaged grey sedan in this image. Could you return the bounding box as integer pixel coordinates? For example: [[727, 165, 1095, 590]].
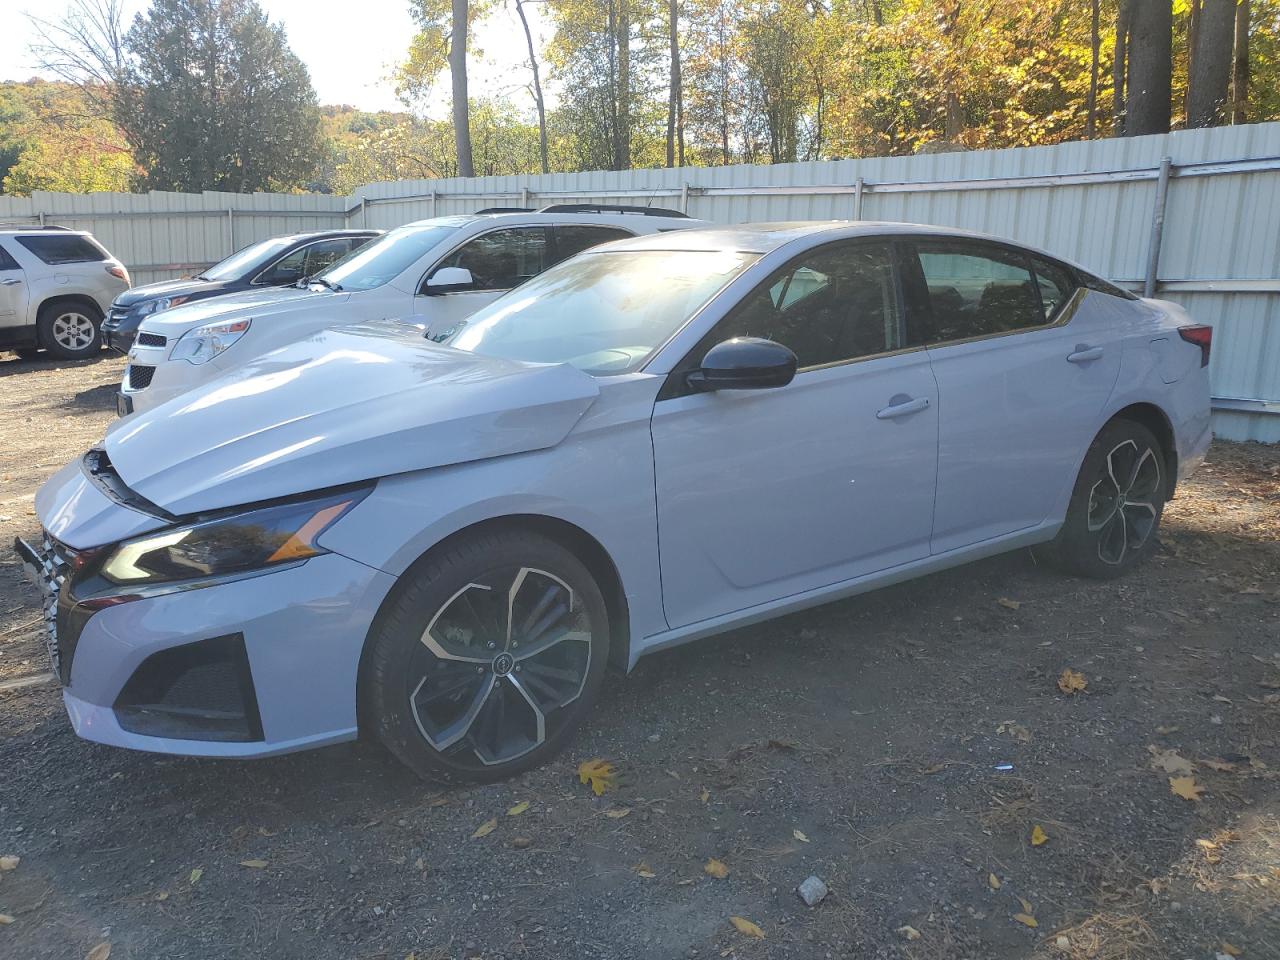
[[447, 250, 758, 376]]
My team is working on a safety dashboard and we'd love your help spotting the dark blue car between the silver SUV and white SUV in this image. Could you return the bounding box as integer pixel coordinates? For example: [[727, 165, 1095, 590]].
[[102, 230, 381, 353]]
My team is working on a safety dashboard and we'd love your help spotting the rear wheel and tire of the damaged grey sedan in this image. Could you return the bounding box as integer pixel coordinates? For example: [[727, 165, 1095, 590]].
[[1037, 420, 1169, 580]]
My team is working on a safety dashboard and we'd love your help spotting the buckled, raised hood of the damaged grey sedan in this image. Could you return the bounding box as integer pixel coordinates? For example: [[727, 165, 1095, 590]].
[[99, 320, 599, 515]]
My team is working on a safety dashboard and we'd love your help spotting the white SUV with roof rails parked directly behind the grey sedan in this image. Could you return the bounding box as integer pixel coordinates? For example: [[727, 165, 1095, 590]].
[[116, 205, 707, 416]]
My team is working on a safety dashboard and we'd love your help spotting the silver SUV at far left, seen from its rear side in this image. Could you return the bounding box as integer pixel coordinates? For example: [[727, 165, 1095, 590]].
[[0, 227, 129, 360]]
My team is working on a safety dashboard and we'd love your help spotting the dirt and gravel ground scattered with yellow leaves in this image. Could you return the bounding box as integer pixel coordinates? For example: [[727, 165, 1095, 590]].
[[0, 358, 1280, 960]]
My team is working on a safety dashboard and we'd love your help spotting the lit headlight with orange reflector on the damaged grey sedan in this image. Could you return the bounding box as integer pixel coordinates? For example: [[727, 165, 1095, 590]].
[[97, 486, 372, 586]]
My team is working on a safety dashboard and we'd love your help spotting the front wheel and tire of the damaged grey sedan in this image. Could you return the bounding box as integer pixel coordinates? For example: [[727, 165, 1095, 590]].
[[360, 530, 609, 782]]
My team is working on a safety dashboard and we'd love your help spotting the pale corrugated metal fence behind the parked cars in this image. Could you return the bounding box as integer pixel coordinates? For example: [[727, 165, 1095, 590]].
[[0, 123, 1280, 442]]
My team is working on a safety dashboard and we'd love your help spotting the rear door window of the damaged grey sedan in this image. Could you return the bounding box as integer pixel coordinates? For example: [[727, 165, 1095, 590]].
[[916, 242, 1044, 343]]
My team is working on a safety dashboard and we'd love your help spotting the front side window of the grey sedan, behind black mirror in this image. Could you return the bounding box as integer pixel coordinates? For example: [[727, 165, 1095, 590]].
[[698, 243, 902, 367]]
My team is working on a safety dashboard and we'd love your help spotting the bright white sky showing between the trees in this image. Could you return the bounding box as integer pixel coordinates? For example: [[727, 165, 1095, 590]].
[[0, 0, 550, 116]]
